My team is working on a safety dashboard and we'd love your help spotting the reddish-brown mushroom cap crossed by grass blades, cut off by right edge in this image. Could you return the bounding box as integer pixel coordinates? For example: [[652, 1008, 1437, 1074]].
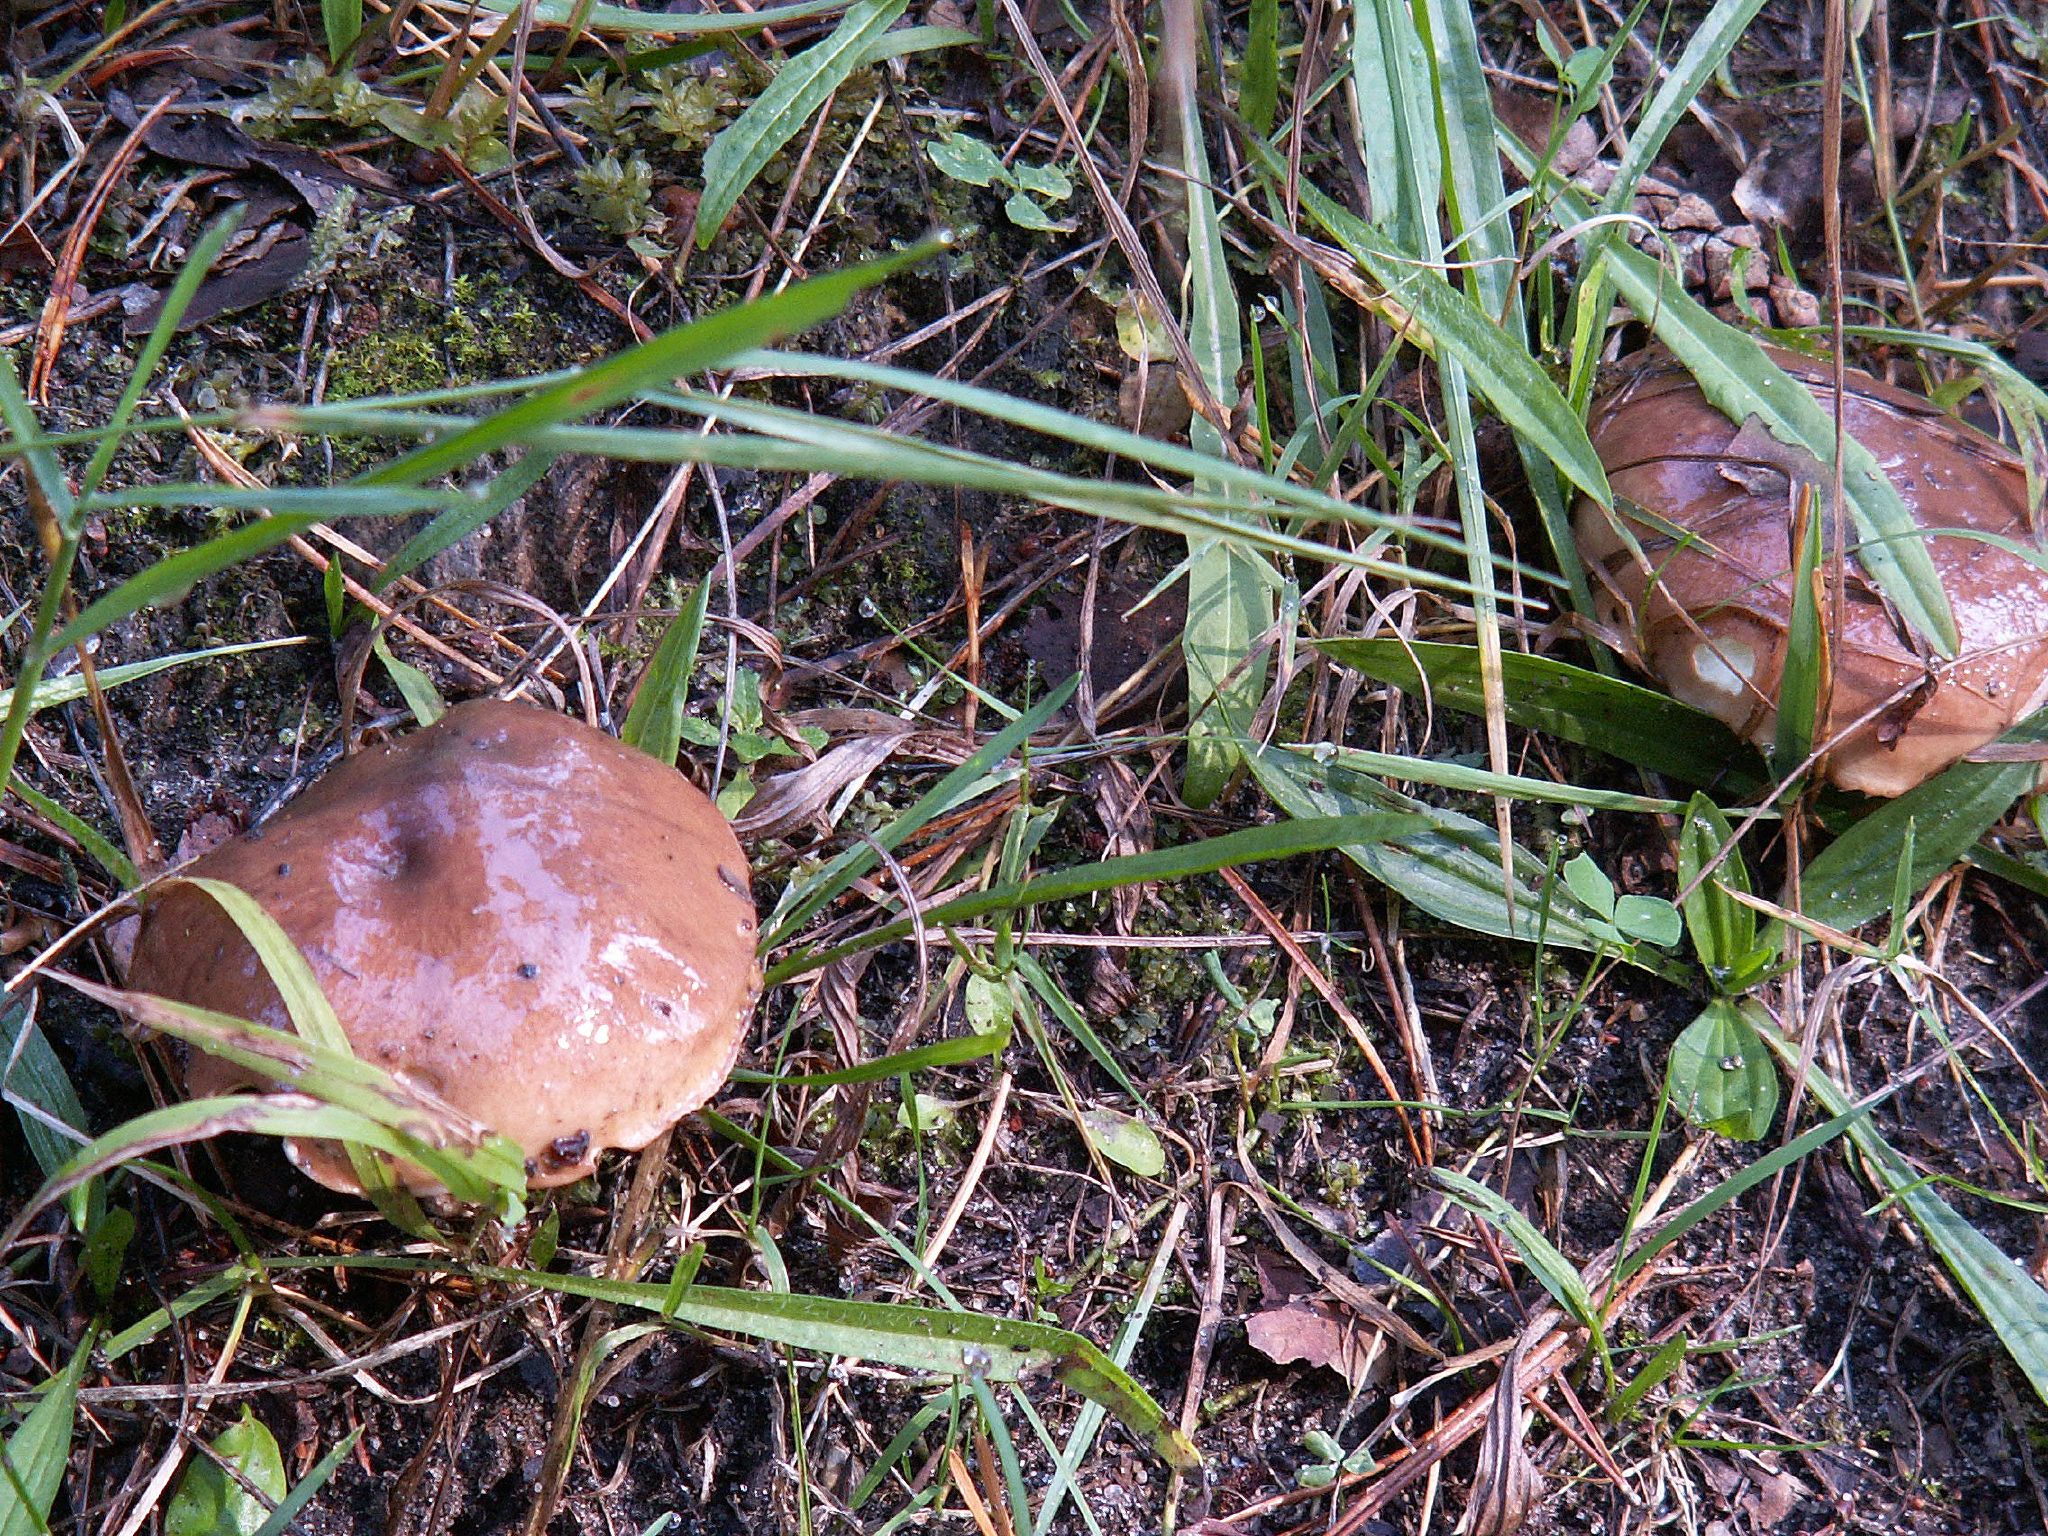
[[1573, 348, 2048, 795]]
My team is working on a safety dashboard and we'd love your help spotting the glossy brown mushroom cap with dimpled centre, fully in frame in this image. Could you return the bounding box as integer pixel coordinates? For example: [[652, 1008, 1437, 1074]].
[[129, 700, 760, 1192]]
